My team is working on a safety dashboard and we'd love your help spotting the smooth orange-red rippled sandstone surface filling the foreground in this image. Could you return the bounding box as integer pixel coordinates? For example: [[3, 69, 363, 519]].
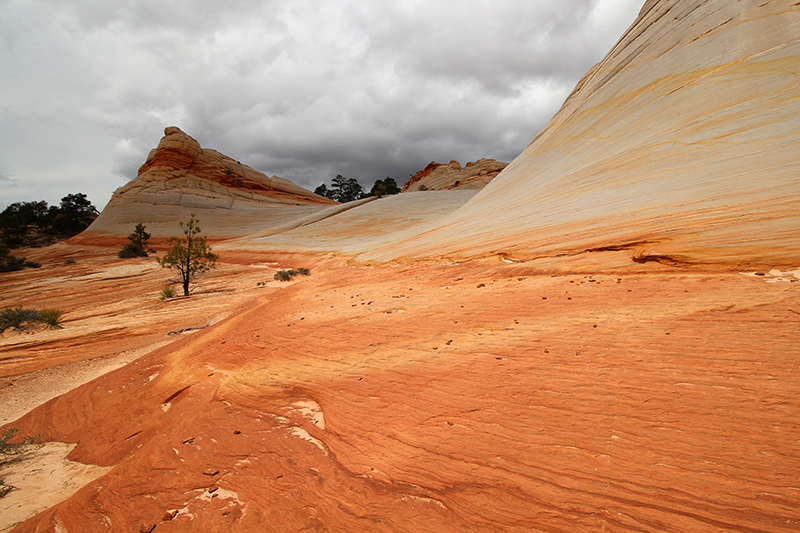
[[6, 260, 800, 532]]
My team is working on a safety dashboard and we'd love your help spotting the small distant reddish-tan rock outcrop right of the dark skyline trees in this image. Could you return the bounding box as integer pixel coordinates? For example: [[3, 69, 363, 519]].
[[402, 159, 508, 192]]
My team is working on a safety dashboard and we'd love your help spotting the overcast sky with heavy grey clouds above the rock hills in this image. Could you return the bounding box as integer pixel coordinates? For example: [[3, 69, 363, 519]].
[[0, 0, 643, 208]]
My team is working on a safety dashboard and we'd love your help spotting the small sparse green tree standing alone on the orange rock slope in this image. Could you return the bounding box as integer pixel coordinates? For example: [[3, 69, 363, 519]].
[[158, 213, 219, 296]]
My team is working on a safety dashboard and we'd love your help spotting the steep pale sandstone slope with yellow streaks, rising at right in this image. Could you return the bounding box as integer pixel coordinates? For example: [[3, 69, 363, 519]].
[[364, 0, 800, 268]]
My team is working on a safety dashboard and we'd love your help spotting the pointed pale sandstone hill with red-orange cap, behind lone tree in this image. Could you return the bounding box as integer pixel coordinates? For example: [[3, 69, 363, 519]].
[[76, 127, 334, 244]]
